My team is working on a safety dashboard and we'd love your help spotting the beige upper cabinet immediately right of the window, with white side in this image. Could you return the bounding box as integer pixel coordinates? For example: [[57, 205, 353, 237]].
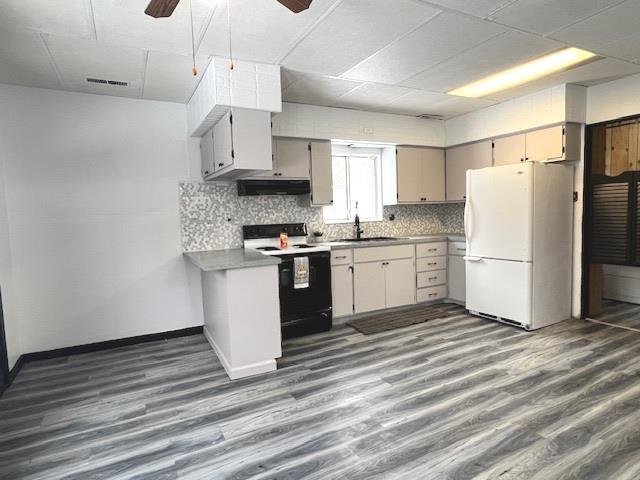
[[382, 147, 446, 205]]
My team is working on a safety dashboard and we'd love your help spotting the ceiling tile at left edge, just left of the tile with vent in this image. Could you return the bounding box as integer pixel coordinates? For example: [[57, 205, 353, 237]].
[[0, 28, 62, 89]]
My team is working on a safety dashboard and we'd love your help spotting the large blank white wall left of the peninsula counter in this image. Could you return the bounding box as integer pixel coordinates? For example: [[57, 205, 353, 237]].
[[0, 85, 203, 368]]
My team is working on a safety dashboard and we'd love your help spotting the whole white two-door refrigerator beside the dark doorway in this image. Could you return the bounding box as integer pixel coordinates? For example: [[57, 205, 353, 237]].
[[464, 162, 573, 330]]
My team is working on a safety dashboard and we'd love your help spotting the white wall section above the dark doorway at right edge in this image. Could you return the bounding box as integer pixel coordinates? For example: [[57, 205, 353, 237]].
[[587, 75, 640, 123]]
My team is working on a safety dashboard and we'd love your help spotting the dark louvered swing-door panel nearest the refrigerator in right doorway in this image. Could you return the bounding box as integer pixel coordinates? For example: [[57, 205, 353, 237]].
[[591, 179, 630, 264]]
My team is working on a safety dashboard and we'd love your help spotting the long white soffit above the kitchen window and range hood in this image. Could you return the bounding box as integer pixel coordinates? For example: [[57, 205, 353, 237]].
[[273, 103, 445, 147]]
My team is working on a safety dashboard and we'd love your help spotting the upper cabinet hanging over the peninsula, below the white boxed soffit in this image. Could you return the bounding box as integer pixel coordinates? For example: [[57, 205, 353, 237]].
[[200, 108, 271, 180]]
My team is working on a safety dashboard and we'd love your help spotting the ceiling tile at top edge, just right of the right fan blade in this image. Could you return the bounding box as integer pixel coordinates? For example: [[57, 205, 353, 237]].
[[283, 0, 439, 75]]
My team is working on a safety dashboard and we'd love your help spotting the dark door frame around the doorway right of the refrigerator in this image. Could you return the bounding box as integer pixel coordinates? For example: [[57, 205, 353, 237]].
[[580, 113, 640, 319]]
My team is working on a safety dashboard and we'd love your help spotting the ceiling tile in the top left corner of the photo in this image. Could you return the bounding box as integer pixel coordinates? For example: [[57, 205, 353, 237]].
[[0, 0, 94, 38]]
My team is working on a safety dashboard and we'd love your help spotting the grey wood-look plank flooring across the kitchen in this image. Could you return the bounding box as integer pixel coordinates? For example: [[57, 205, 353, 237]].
[[0, 307, 640, 480]]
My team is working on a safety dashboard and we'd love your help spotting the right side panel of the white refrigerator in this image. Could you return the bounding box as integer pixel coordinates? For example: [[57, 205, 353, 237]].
[[532, 163, 574, 328]]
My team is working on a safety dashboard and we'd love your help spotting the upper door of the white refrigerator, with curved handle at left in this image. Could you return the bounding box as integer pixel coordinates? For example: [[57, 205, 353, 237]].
[[465, 163, 533, 262]]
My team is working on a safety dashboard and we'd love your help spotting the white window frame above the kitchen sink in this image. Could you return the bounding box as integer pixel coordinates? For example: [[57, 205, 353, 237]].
[[322, 145, 384, 224]]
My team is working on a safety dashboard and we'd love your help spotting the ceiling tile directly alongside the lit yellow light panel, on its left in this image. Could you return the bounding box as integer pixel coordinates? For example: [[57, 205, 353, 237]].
[[402, 31, 563, 92]]
